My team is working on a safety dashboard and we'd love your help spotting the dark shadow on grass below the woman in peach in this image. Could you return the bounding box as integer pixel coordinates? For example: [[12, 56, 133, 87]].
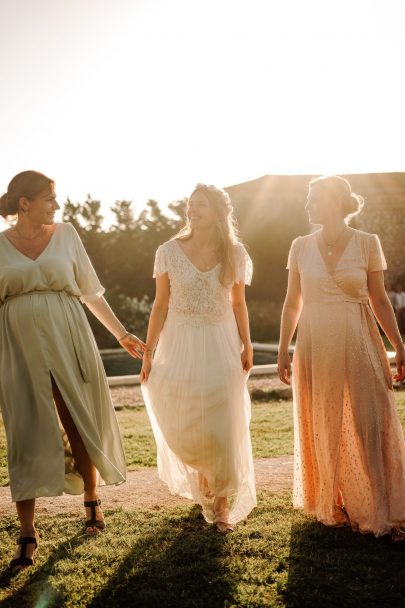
[[285, 521, 405, 608]]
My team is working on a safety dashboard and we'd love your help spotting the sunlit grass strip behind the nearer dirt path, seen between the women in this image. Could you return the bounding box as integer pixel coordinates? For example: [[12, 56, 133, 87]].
[[0, 391, 405, 486]]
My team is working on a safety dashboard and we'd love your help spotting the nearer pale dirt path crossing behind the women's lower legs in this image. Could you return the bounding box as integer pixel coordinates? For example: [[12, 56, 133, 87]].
[[0, 456, 293, 515]]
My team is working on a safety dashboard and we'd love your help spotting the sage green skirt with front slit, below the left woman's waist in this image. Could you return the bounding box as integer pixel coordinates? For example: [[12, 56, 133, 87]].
[[0, 292, 125, 501]]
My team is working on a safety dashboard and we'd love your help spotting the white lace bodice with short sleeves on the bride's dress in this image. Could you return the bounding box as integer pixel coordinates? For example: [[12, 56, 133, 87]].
[[153, 240, 253, 325]]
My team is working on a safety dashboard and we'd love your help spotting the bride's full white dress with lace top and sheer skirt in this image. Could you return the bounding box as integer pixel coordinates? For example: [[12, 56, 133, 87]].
[[142, 240, 256, 524]]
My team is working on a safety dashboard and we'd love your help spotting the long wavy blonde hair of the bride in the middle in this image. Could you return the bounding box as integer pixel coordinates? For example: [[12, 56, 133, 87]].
[[173, 184, 240, 286]]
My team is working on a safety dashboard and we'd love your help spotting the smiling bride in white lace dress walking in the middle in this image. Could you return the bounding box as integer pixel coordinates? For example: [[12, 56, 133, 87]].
[[141, 184, 256, 532]]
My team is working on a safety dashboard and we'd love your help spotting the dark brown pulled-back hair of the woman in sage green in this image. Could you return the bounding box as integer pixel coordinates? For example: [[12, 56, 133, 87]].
[[0, 171, 55, 217]]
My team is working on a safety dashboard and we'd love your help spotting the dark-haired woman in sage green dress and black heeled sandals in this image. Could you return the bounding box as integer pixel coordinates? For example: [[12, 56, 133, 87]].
[[0, 171, 144, 570]]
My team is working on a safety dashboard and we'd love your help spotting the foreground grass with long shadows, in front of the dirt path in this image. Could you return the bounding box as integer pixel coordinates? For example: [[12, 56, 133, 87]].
[[0, 493, 405, 608]]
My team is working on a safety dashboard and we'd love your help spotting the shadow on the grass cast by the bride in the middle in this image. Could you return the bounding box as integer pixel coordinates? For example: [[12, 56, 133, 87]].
[[88, 507, 234, 608]]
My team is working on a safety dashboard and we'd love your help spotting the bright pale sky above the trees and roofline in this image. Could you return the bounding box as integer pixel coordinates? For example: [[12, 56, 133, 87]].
[[0, 0, 405, 218]]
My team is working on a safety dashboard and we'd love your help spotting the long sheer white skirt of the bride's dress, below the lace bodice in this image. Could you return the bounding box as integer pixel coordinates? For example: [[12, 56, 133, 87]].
[[142, 310, 256, 523]]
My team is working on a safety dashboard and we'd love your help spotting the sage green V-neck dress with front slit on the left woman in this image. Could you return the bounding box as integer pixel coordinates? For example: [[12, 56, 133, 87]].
[[0, 223, 125, 501]]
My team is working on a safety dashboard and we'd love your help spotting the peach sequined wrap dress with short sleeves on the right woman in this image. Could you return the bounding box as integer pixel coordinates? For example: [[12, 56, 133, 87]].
[[287, 230, 405, 536]]
